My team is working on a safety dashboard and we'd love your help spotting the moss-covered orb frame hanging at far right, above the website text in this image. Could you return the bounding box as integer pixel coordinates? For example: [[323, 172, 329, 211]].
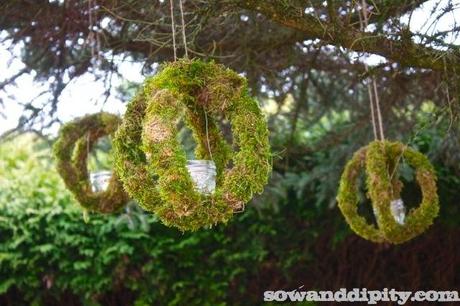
[[337, 141, 439, 244]]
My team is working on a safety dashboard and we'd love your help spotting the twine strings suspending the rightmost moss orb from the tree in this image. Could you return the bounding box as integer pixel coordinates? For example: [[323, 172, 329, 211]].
[[358, 0, 385, 140]]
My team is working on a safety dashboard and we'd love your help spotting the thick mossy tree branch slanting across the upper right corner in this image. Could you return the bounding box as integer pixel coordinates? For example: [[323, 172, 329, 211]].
[[233, 0, 460, 72]]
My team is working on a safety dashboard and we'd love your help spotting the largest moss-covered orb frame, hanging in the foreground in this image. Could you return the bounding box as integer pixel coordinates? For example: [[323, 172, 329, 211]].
[[114, 60, 271, 230]]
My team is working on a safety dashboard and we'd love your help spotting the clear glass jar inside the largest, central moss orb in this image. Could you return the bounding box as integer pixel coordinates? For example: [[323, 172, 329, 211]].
[[187, 159, 216, 194]]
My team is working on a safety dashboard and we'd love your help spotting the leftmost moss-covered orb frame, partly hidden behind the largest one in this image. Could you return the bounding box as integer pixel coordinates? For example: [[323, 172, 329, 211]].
[[54, 113, 129, 213]]
